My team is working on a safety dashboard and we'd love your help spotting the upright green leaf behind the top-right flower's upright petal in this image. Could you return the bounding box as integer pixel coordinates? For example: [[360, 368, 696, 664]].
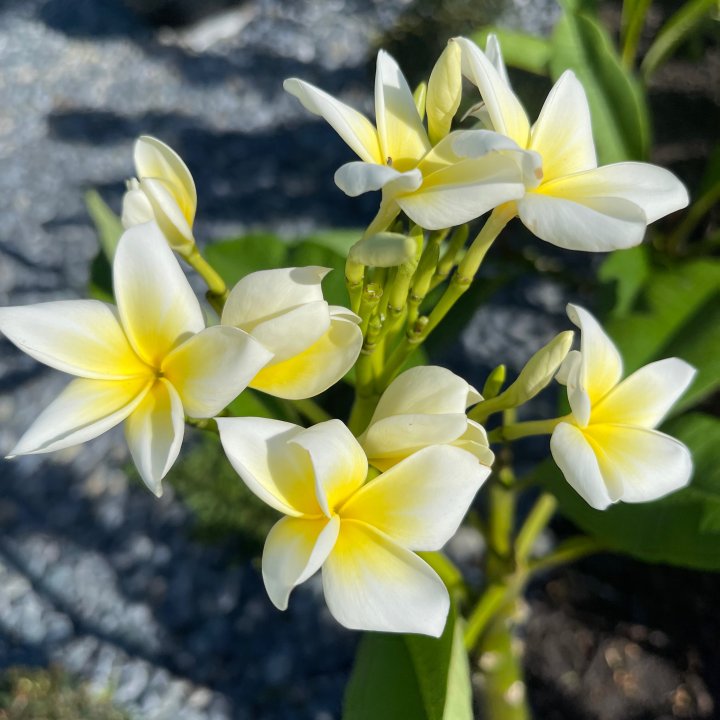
[[550, 8, 650, 165]]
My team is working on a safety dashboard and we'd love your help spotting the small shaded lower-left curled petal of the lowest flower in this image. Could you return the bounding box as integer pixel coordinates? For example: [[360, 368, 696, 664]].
[[262, 515, 340, 610]]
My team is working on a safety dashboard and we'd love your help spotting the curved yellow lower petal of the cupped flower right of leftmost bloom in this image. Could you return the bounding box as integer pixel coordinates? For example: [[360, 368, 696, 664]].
[[250, 306, 363, 400]]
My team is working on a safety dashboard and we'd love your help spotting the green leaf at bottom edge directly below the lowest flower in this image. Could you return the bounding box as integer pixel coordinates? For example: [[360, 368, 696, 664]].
[[343, 607, 473, 720]]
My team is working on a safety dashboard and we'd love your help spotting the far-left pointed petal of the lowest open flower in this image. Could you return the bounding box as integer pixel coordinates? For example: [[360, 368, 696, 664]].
[[217, 417, 322, 517]]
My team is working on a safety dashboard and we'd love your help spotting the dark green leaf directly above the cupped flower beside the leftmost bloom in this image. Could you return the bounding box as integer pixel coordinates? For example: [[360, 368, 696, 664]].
[[203, 233, 288, 288]]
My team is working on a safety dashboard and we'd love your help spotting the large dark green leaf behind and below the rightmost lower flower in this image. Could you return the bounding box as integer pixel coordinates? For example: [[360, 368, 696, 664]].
[[534, 413, 720, 570]]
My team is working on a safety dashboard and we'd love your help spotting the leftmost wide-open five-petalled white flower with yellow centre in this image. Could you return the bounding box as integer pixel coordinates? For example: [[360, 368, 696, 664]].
[[0, 223, 272, 496]]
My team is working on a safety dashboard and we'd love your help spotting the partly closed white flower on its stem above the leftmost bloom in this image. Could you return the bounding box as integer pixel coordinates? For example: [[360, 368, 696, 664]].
[[121, 135, 197, 255]]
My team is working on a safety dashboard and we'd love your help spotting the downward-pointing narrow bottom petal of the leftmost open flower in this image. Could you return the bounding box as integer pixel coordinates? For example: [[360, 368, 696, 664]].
[[125, 378, 185, 497]]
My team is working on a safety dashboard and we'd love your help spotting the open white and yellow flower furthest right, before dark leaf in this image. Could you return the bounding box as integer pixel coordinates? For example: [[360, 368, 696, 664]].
[[550, 305, 695, 510]]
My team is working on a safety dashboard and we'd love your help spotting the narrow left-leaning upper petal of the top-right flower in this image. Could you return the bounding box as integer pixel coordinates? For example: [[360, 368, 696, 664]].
[[455, 38, 530, 148]]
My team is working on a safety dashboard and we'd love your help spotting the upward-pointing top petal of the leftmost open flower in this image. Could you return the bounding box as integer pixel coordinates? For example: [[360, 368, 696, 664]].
[[113, 223, 205, 368]]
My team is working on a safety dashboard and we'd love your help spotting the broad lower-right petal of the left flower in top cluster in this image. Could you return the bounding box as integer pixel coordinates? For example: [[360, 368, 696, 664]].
[[395, 153, 525, 230]]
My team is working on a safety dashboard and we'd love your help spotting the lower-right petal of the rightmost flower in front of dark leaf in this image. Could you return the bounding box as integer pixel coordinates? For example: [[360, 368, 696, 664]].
[[585, 424, 692, 503]]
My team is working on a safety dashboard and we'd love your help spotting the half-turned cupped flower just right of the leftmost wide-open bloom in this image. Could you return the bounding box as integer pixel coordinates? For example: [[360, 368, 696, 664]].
[[221, 266, 363, 400]]
